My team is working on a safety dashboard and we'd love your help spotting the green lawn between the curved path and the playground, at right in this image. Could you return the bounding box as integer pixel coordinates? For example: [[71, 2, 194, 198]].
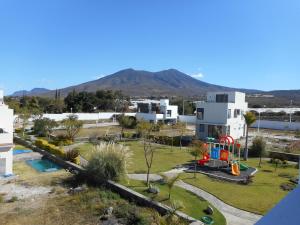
[[181, 159, 298, 214]]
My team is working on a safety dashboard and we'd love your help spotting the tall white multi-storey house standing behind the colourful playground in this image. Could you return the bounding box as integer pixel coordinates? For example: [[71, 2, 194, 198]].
[[196, 92, 248, 139]]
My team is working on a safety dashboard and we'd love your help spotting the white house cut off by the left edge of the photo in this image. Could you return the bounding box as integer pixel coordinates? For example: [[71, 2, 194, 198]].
[[0, 90, 14, 176]]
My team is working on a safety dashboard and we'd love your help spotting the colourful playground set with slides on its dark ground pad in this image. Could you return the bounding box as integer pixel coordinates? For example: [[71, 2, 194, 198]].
[[185, 135, 257, 183]]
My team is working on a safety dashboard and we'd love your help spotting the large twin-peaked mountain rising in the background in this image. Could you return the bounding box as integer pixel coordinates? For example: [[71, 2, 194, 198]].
[[41, 69, 257, 96]]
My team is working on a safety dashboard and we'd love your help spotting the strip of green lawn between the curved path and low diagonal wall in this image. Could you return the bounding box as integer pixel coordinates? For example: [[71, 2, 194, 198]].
[[121, 180, 226, 225]]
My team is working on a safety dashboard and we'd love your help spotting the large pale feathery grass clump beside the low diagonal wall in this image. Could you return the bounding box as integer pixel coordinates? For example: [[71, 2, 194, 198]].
[[85, 142, 130, 184]]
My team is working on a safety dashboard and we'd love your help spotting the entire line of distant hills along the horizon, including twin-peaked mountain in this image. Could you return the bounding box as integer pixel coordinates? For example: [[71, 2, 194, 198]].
[[9, 69, 300, 107]]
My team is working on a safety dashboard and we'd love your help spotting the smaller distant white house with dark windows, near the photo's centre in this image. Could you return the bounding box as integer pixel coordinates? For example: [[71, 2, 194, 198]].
[[136, 99, 178, 123]]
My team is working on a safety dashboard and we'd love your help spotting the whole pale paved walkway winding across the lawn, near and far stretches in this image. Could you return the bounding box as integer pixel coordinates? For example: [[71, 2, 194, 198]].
[[128, 173, 262, 225]]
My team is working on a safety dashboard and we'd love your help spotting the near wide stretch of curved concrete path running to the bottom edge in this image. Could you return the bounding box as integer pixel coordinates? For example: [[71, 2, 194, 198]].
[[176, 181, 262, 225]]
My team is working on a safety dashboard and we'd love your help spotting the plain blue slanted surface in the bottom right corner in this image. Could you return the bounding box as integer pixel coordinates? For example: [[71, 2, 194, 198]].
[[256, 186, 300, 225]]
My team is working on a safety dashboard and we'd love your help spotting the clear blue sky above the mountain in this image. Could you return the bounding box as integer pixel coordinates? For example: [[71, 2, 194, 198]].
[[0, 0, 300, 94]]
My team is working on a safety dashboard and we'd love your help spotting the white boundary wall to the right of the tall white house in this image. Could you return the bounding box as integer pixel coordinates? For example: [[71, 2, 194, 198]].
[[251, 120, 300, 130]]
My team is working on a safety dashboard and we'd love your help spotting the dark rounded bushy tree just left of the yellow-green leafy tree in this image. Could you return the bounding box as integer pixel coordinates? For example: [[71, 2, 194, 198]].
[[33, 118, 58, 139]]
